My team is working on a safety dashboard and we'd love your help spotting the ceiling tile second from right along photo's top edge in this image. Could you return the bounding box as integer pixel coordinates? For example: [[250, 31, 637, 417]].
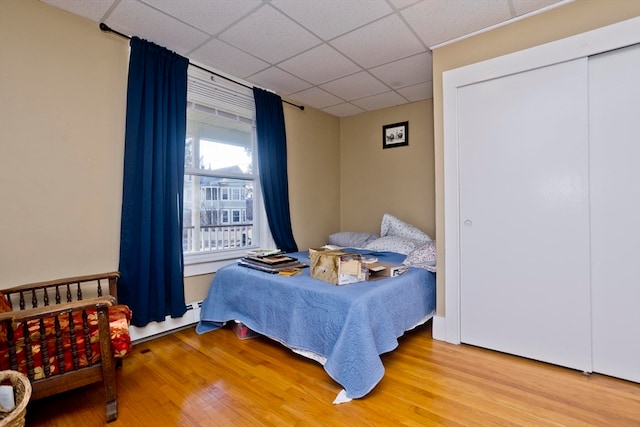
[[402, 0, 511, 47]]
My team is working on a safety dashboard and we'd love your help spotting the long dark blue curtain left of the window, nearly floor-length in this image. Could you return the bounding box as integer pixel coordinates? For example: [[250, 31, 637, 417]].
[[118, 37, 189, 326]]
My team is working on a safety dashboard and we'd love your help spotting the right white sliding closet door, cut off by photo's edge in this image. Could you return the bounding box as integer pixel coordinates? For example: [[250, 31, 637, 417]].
[[589, 45, 640, 382]]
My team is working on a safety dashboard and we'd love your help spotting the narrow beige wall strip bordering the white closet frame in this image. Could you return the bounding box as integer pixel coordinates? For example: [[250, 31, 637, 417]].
[[433, 0, 640, 316]]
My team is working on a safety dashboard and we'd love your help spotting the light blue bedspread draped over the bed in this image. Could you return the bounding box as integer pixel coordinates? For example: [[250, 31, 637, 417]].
[[196, 249, 436, 398]]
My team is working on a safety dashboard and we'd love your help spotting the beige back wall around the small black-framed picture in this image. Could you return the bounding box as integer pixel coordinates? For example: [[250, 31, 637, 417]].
[[334, 99, 435, 237]]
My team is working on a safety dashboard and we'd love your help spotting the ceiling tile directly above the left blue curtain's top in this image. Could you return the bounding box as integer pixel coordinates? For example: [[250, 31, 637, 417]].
[[106, 0, 208, 55]]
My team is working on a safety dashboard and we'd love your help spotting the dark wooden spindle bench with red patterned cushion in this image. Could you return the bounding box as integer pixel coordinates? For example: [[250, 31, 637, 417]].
[[0, 272, 131, 422]]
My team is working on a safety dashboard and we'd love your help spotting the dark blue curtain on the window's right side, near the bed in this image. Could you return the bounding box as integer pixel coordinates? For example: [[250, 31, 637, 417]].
[[253, 87, 298, 252]]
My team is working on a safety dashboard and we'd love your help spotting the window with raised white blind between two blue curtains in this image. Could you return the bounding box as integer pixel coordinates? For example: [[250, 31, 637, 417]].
[[182, 67, 271, 275]]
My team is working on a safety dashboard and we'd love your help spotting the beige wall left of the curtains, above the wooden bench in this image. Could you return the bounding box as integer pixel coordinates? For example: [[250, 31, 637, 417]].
[[0, 0, 128, 287]]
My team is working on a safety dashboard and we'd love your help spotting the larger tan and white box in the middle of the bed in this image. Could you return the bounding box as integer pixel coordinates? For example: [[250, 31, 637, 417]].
[[309, 248, 367, 285]]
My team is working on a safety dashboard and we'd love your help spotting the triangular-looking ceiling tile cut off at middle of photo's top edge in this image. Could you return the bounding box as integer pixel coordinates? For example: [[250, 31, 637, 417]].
[[271, 0, 393, 40]]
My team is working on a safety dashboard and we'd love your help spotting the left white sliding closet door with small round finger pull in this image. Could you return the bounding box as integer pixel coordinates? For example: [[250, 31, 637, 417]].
[[458, 58, 591, 371]]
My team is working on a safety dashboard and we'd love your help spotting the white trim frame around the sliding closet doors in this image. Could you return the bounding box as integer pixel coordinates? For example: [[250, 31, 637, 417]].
[[440, 17, 640, 344]]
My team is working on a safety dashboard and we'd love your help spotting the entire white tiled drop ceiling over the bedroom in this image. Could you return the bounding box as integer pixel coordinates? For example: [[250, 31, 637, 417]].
[[41, 0, 570, 117]]
